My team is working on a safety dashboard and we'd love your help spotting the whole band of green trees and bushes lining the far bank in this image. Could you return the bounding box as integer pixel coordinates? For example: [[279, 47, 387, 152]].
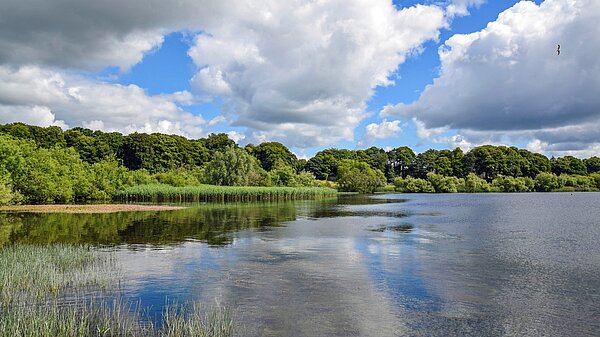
[[0, 123, 600, 203]]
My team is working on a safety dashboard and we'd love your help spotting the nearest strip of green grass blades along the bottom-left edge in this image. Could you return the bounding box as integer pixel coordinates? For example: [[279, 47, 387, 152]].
[[0, 299, 233, 337]]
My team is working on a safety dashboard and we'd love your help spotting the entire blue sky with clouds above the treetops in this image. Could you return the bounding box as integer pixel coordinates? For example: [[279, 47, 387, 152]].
[[0, 0, 600, 158]]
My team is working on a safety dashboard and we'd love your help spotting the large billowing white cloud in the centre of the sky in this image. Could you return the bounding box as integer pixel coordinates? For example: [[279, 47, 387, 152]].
[[189, 0, 446, 147]]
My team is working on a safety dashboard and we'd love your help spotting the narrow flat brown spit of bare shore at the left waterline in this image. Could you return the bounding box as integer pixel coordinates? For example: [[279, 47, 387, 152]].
[[0, 204, 185, 214]]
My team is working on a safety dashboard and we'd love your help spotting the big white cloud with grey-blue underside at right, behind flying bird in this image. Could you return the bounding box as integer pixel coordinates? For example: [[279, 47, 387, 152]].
[[381, 0, 600, 153]]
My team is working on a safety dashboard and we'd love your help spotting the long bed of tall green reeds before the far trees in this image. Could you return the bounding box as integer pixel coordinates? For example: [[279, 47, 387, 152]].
[[116, 184, 337, 201]]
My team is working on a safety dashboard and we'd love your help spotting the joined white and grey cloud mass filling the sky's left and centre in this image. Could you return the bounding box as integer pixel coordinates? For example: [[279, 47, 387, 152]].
[[0, 0, 450, 147]]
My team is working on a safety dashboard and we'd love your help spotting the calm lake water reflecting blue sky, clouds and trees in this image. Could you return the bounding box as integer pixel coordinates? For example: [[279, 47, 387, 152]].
[[0, 193, 600, 336]]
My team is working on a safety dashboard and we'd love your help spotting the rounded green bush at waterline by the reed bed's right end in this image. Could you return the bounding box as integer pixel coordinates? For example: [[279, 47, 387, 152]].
[[337, 159, 386, 193]]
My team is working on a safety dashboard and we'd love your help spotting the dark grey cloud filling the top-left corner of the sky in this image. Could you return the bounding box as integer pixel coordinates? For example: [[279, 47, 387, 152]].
[[0, 0, 233, 70]]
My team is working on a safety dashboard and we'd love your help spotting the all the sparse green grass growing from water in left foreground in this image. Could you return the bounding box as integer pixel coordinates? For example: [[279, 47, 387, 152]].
[[0, 245, 233, 337]]
